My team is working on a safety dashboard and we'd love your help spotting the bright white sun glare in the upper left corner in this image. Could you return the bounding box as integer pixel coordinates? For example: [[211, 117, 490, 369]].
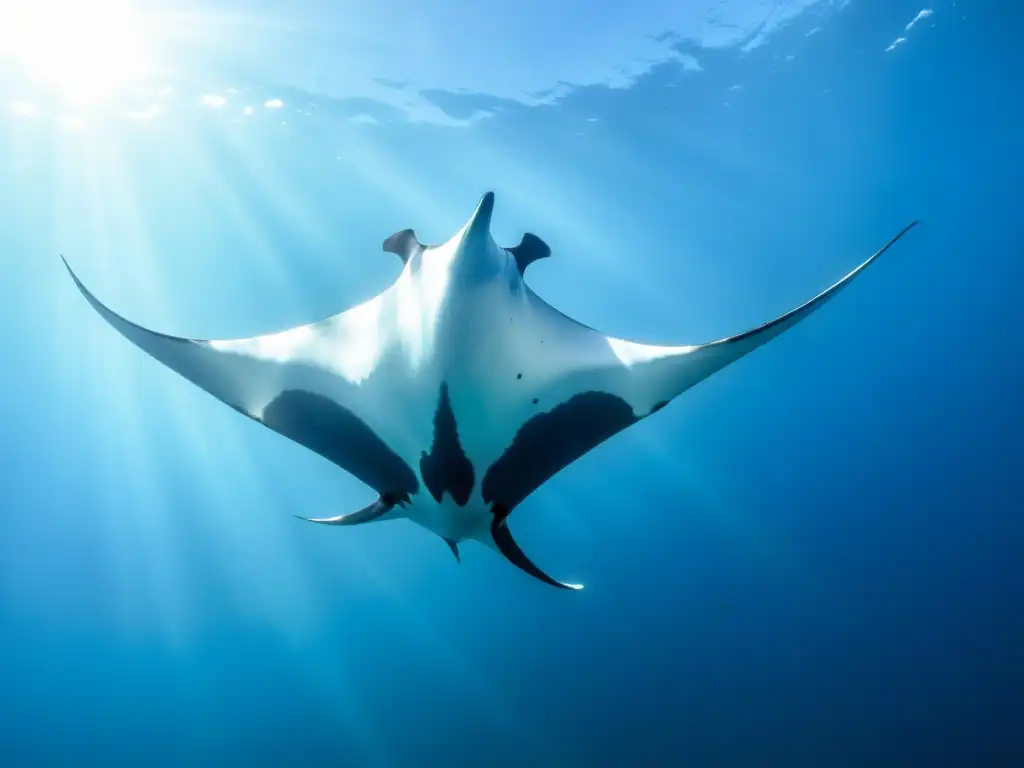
[[0, 0, 151, 103]]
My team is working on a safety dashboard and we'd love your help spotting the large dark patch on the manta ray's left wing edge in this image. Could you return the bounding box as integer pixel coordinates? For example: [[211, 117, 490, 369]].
[[260, 389, 420, 502]]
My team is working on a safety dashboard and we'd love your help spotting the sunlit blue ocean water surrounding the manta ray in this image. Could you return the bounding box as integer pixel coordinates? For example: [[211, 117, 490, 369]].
[[0, 0, 1024, 768]]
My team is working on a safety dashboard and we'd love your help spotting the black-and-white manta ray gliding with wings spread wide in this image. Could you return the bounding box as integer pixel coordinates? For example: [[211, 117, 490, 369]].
[[61, 191, 918, 590]]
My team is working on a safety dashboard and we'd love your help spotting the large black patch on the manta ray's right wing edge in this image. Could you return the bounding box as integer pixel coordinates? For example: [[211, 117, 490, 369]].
[[481, 392, 640, 510]]
